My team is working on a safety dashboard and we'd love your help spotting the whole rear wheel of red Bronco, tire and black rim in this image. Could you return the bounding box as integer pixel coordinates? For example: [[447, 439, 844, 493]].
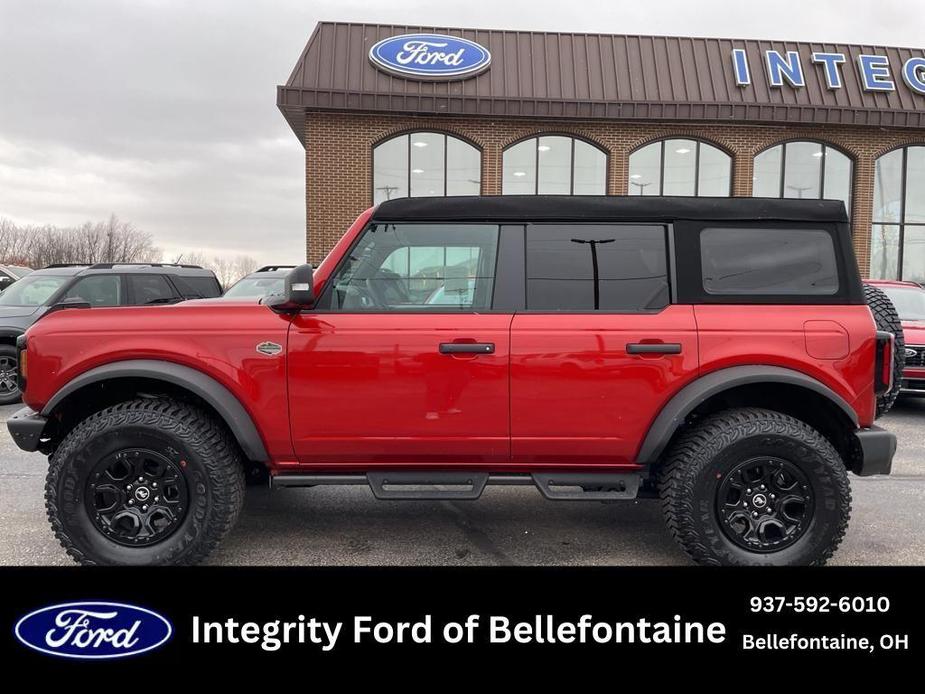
[[659, 408, 851, 565]]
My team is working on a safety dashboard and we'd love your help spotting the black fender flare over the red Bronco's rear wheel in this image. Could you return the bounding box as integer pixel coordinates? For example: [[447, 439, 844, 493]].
[[636, 365, 859, 465]]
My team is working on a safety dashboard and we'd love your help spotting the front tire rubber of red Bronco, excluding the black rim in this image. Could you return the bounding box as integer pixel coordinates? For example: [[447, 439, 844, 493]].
[[45, 399, 244, 565]]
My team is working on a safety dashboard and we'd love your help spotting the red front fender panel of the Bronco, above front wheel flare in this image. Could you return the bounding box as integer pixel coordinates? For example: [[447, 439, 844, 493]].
[[23, 302, 292, 459]]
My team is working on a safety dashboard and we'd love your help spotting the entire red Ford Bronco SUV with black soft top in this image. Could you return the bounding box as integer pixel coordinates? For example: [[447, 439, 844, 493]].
[[9, 196, 896, 564]]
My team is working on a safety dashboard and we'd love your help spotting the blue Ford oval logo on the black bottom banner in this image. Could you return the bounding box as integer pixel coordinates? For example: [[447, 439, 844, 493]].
[[14, 602, 173, 659]]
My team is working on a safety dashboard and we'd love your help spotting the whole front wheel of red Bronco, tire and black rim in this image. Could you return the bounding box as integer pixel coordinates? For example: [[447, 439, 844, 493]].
[[45, 399, 244, 565]]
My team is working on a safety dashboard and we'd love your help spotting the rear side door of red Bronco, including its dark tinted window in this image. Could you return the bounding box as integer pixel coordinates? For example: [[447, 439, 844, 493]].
[[511, 223, 698, 466]]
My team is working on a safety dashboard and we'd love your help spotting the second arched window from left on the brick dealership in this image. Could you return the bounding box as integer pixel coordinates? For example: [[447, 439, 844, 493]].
[[501, 135, 607, 195]]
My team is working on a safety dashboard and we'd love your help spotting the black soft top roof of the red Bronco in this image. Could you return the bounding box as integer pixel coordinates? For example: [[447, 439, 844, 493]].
[[372, 195, 848, 222]]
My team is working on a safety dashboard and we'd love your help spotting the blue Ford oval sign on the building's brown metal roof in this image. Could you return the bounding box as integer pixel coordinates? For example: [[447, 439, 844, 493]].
[[369, 34, 491, 79]]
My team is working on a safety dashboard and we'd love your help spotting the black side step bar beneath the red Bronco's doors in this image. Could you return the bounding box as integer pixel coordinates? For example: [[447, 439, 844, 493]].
[[270, 470, 641, 501]]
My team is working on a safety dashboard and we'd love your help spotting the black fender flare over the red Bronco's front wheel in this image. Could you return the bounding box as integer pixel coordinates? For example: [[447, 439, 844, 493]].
[[41, 359, 270, 463]]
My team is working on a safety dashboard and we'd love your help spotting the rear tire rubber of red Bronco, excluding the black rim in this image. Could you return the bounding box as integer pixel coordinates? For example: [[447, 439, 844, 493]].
[[658, 408, 851, 566]]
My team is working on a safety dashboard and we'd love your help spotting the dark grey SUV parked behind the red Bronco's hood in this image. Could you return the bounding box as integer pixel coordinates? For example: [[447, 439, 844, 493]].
[[0, 263, 222, 405]]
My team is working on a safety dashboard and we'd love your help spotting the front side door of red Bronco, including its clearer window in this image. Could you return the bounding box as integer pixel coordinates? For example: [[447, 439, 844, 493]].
[[288, 223, 512, 467]]
